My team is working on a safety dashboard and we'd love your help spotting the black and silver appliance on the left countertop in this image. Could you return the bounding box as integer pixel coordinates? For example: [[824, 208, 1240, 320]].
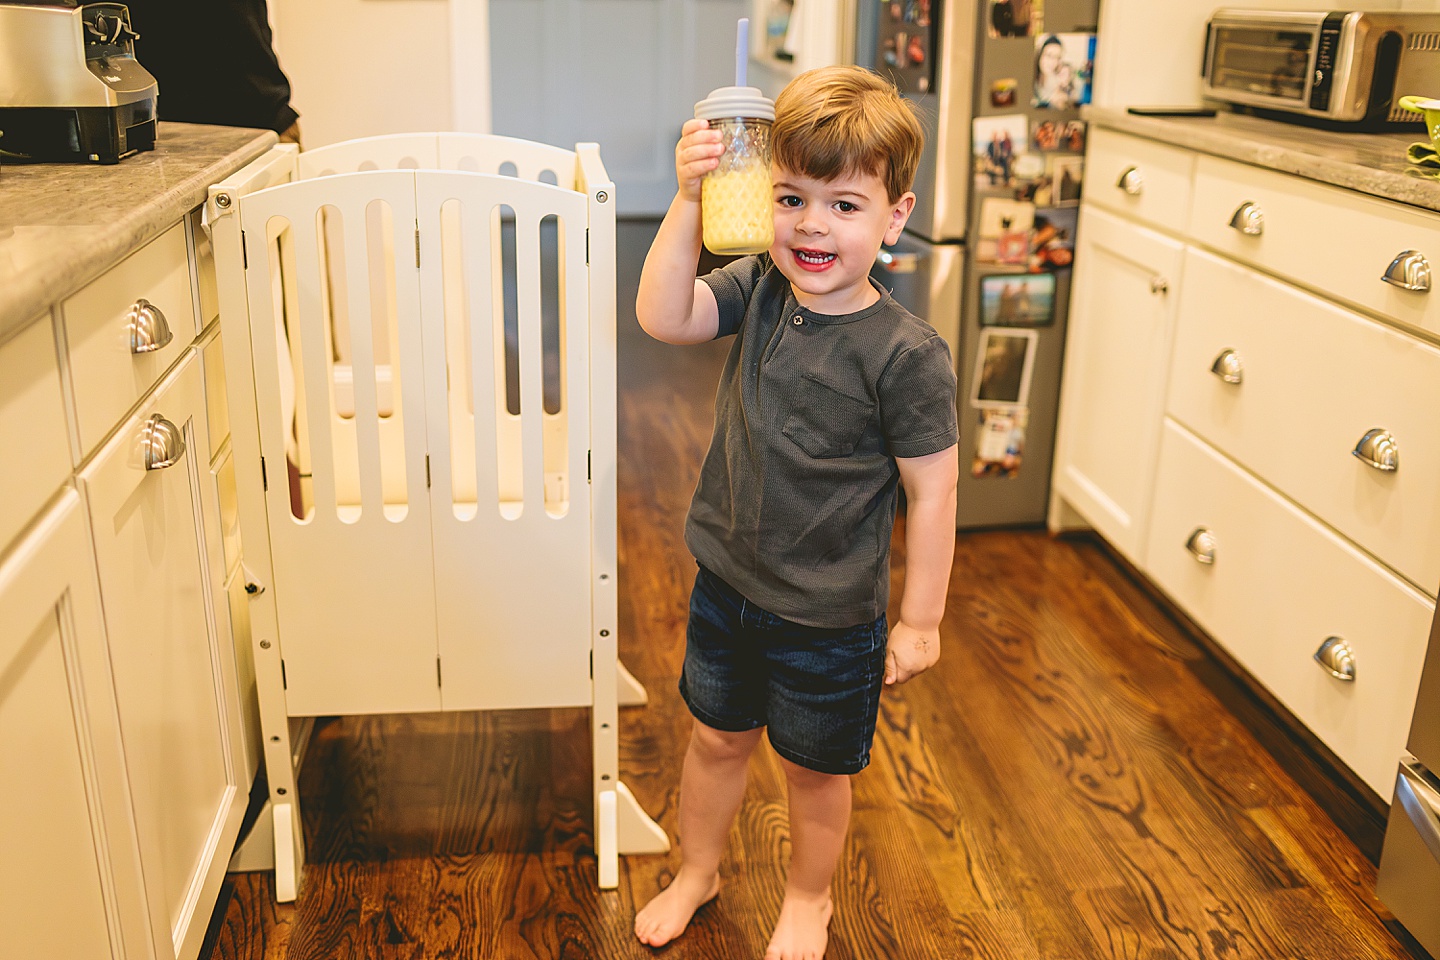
[[0, 0, 158, 164]]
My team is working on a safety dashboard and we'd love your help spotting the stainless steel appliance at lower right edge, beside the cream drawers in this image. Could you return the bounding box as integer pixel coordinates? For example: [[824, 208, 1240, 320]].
[[1375, 595, 1440, 957]]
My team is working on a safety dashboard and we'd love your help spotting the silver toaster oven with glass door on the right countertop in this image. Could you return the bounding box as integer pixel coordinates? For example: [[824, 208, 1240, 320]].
[[1202, 10, 1440, 127]]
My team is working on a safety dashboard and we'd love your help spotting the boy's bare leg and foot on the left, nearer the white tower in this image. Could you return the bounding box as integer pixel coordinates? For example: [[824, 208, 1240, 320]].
[[635, 721, 765, 947]]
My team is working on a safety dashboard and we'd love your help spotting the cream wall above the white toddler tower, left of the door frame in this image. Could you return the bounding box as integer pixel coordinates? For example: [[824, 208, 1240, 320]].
[[271, 0, 455, 148]]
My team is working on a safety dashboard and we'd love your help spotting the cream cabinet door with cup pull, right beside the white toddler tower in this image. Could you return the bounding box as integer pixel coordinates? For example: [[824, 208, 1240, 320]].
[[81, 353, 246, 960]]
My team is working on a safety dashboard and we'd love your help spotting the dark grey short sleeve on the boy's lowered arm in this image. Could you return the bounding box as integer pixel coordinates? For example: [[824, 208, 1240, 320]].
[[878, 335, 959, 458]]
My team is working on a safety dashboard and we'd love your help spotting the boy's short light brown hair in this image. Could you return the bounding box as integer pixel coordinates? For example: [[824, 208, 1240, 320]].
[[770, 66, 924, 203]]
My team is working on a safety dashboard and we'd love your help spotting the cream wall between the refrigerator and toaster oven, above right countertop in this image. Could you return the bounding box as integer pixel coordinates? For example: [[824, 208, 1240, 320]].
[[1093, 0, 1440, 107]]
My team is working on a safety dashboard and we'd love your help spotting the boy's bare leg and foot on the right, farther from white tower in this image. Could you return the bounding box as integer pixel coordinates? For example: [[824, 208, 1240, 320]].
[[765, 757, 850, 960]]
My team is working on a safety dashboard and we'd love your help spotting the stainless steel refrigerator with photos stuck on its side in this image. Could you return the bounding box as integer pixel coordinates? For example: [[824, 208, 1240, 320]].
[[855, 0, 1103, 528]]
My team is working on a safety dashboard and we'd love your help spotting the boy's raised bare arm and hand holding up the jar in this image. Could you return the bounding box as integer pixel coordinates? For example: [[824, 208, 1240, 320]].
[[635, 119, 724, 344]]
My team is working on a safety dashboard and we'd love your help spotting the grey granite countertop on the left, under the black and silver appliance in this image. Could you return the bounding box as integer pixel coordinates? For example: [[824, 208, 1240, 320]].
[[0, 122, 276, 341]]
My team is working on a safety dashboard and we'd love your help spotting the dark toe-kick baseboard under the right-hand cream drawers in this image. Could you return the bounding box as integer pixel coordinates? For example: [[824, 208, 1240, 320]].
[[1061, 531, 1390, 865]]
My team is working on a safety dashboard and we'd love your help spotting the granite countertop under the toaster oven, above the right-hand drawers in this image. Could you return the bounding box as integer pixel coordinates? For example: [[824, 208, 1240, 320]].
[[1084, 107, 1440, 210]]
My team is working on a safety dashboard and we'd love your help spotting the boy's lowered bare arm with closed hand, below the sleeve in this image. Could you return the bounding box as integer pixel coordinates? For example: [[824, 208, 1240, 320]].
[[886, 445, 960, 684]]
